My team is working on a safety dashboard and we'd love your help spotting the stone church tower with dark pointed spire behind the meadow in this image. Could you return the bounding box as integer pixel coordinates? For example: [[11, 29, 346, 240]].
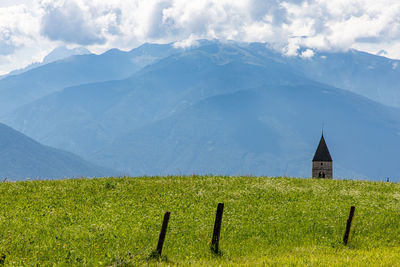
[[312, 133, 333, 179]]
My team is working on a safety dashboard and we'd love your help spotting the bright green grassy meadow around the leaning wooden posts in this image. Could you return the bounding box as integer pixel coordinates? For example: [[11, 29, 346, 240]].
[[0, 176, 400, 266]]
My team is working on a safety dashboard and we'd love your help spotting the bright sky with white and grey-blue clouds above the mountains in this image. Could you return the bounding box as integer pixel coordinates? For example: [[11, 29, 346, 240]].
[[0, 0, 400, 74]]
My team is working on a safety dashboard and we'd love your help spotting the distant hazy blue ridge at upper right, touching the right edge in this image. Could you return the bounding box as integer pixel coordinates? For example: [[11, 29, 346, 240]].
[[289, 50, 400, 107]]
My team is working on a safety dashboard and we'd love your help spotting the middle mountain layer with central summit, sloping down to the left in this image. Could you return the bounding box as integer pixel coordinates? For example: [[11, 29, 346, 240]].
[[6, 43, 306, 157]]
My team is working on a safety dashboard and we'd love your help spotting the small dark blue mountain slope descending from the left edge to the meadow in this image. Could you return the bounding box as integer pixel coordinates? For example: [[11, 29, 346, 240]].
[[0, 123, 118, 180]]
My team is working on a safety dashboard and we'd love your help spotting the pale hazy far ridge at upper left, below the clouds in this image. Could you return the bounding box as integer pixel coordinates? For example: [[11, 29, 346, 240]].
[[0, 44, 176, 116]]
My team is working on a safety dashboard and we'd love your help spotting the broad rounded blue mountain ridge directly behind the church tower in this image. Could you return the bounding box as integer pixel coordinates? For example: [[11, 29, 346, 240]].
[[92, 83, 400, 180]]
